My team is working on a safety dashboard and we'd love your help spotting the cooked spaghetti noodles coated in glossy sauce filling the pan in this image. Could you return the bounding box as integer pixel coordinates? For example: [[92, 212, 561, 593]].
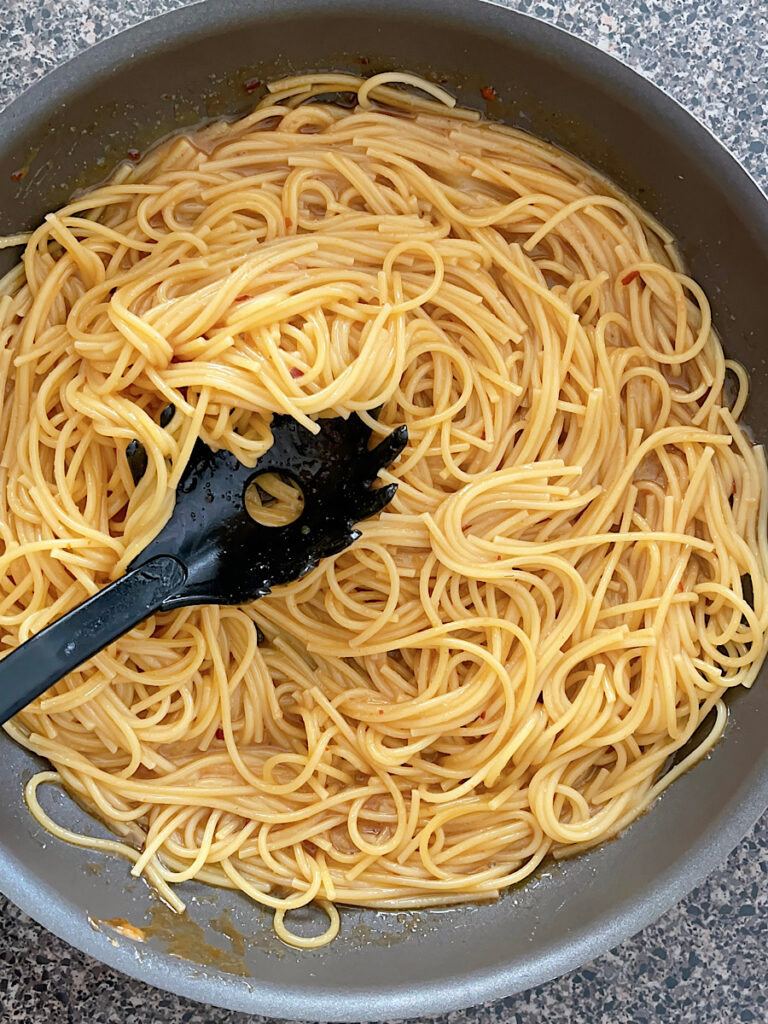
[[0, 74, 768, 947]]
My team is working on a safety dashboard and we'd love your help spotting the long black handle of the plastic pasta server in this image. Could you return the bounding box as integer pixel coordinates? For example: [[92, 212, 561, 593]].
[[0, 555, 186, 724]]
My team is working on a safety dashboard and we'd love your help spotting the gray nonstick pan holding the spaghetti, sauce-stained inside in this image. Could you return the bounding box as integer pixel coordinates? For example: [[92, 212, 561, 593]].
[[0, 0, 768, 1021]]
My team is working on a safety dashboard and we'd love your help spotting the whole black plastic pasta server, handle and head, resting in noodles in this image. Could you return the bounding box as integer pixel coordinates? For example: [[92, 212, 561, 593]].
[[0, 416, 408, 723]]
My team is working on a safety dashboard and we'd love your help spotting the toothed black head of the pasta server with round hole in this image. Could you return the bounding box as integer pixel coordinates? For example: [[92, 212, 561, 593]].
[[129, 416, 408, 608]]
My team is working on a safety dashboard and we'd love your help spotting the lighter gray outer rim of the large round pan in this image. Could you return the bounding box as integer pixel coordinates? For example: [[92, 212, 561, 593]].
[[0, 0, 768, 1021]]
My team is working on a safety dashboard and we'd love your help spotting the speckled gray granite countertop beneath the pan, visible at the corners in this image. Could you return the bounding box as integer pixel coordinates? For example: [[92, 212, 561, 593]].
[[0, 0, 768, 1024]]
